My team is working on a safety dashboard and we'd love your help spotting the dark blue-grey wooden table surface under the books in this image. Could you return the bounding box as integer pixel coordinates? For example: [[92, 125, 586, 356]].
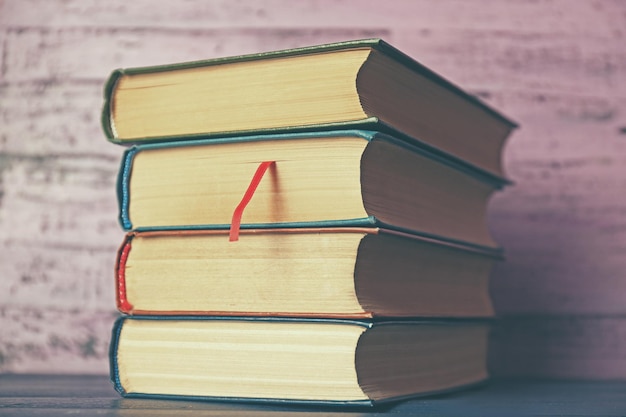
[[0, 375, 626, 417]]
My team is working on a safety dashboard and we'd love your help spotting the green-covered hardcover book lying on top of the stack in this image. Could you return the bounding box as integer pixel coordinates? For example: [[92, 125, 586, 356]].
[[102, 39, 516, 177]]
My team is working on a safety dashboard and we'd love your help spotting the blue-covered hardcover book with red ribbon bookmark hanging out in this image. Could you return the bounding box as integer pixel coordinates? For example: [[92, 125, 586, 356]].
[[119, 131, 504, 249]]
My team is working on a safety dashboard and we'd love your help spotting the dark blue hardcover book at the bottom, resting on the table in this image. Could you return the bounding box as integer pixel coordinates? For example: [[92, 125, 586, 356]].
[[110, 316, 489, 405]]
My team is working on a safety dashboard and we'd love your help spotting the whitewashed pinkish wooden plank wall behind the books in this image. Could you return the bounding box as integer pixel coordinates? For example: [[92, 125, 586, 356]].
[[0, 0, 626, 379]]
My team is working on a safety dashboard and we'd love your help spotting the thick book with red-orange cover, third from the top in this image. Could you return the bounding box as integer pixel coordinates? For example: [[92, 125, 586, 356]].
[[116, 227, 499, 318]]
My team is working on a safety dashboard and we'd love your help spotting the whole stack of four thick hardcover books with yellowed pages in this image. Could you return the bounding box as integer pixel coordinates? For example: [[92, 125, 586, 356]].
[[103, 39, 515, 405]]
